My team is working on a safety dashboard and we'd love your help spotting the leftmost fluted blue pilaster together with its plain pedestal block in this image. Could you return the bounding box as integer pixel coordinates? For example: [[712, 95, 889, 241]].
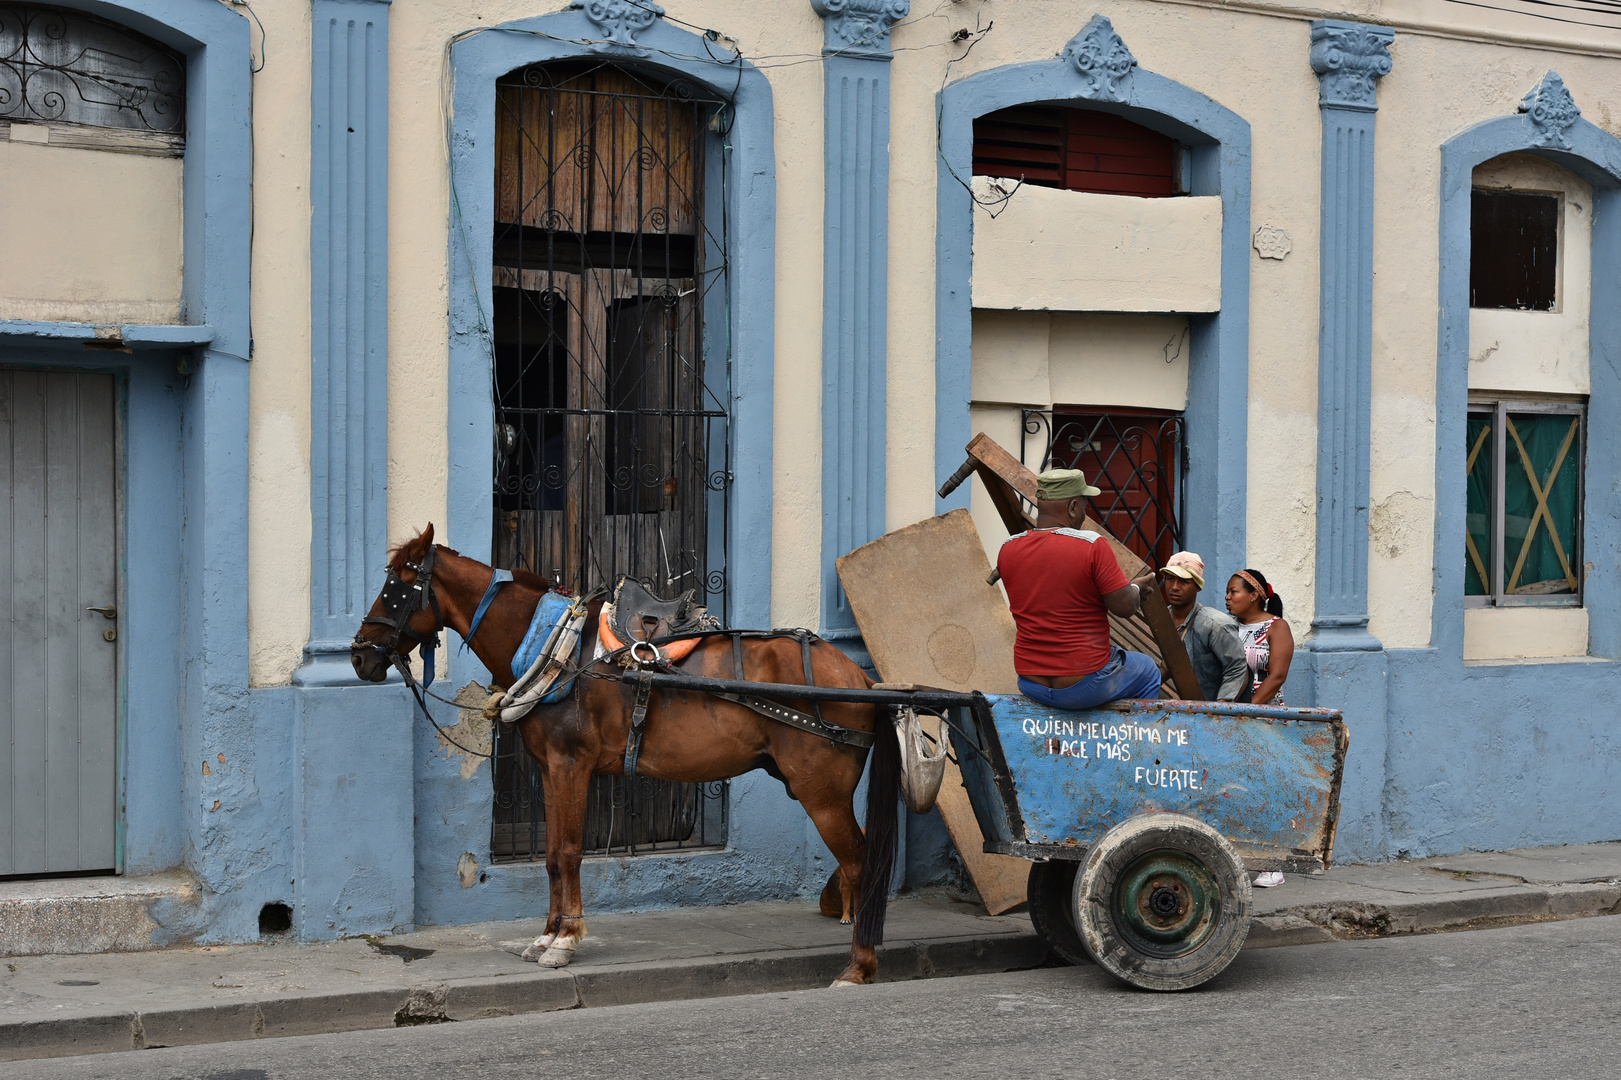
[[292, 0, 417, 941]]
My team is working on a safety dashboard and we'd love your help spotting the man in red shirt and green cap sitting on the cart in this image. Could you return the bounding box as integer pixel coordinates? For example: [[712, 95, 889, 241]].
[[997, 469, 1161, 709]]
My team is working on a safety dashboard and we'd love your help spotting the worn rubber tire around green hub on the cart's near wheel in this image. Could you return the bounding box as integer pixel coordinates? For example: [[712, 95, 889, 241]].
[[1073, 812, 1253, 991]]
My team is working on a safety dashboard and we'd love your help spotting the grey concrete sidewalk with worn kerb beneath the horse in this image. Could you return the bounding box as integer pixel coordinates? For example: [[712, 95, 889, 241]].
[[0, 843, 1621, 1061]]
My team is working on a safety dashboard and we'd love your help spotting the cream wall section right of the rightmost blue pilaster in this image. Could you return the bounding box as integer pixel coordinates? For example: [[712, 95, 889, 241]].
[[1368, 32, 1621, 647]]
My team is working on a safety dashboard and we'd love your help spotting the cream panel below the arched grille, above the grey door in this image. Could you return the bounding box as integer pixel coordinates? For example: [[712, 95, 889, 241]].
[[0, 134, 182, 323]]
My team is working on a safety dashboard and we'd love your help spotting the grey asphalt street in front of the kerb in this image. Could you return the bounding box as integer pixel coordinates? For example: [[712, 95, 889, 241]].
[[12, 916, 1621, 1080]]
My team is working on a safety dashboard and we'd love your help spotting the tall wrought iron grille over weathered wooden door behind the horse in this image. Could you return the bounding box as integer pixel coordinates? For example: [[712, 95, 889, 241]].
[[491, 63, 731, 859]]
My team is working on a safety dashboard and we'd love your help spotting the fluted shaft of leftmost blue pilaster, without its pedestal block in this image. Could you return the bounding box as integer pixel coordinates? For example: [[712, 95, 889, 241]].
[[293, 0, 389, 686]]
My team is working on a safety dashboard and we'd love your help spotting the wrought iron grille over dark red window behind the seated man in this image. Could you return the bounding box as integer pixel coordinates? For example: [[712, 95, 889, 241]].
[[1020, 407, 1187, 566]]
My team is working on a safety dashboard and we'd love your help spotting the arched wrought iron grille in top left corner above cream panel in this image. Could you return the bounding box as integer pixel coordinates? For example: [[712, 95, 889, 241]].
[[0, 3, 186, 133]]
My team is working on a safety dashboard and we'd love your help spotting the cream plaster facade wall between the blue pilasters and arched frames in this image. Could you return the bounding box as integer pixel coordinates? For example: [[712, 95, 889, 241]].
[[235, 0, 1621, 683]]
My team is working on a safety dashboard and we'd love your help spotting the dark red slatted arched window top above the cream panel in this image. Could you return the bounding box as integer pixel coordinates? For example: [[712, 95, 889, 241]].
[[974, 105, 1187, 198]]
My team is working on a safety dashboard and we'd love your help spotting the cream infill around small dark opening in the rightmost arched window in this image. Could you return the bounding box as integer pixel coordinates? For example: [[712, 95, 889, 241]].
[[1469, 154, 1593, 394]]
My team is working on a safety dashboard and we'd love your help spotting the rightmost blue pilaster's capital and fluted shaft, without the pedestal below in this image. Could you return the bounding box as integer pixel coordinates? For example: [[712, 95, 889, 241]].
[[1311, 21, 1396, 652]]
